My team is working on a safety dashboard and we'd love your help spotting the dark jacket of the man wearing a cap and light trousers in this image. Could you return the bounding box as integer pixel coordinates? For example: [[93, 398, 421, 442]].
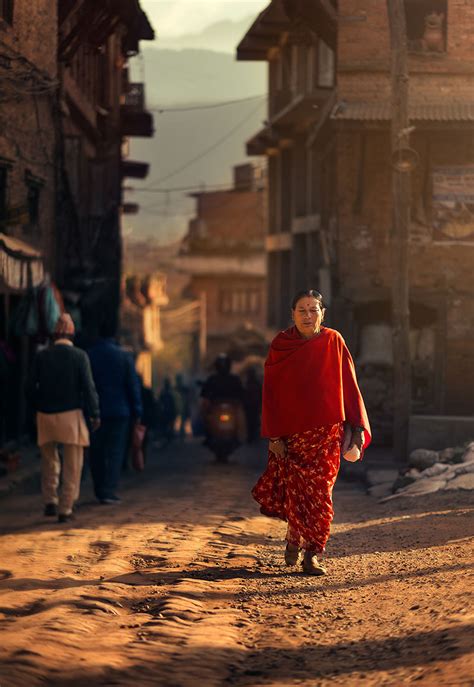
[[27, 343, 100, 418]]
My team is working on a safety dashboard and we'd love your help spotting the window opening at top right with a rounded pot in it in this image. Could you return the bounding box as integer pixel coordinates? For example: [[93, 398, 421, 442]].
[[405, 0, 448, 54]]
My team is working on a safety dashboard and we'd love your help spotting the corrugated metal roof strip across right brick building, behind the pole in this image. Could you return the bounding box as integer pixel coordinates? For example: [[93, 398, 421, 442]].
[[331, 100, 474, 122]]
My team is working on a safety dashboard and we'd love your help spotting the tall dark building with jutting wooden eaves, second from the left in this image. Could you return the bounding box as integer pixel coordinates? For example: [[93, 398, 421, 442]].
[[58, 0, 154, 334]]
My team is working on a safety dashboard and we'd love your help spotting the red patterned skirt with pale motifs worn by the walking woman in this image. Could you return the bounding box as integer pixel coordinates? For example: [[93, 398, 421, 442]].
[[252, 422, 344, 552]]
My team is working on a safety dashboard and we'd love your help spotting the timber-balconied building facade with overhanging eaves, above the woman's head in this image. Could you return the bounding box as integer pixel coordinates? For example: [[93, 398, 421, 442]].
[[237, 1, 336, 329]]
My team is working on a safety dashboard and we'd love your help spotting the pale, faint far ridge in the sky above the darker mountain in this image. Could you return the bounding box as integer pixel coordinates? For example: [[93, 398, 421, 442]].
[[157, 15, 255, 54]]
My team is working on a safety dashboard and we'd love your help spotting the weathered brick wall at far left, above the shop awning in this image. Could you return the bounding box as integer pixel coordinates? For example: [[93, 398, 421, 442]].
[[0, 0, 57, 271]]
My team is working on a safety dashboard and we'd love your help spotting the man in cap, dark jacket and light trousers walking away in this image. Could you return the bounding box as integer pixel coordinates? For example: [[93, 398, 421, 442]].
[[28, 313, 100, 522]]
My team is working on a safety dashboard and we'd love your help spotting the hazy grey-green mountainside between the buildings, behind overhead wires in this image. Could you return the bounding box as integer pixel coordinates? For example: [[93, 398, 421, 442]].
[[125, 48, 267, 243]]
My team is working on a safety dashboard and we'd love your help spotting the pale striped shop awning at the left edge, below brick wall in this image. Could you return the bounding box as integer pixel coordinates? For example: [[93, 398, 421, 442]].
[[0, 232, 44, 291]]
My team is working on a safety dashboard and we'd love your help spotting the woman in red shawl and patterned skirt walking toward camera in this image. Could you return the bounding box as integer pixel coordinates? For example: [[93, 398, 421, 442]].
[[252, 290, 371, 575]]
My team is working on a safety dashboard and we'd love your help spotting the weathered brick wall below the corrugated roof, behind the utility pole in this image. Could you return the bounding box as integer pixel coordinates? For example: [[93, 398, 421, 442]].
[[338, 130, 474, 414]]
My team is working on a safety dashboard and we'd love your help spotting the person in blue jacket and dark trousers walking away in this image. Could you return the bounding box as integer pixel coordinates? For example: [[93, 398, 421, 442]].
[[87, 326, 143, 505]]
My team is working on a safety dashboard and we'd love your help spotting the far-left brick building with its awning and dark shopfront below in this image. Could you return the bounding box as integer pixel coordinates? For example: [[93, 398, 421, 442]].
[[0, 0, 58, 447]]
